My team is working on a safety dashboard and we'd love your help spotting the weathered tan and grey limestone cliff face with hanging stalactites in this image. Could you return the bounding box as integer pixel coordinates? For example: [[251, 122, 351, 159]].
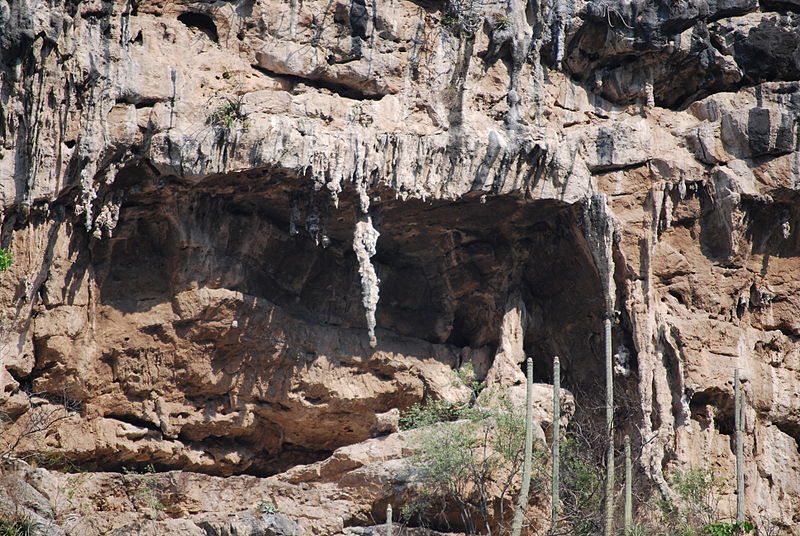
[[0, 0, 800, 534]]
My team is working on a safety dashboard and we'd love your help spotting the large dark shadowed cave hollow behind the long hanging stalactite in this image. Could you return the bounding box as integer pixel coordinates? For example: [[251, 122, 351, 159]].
[[78, 165, 625, 475]]
